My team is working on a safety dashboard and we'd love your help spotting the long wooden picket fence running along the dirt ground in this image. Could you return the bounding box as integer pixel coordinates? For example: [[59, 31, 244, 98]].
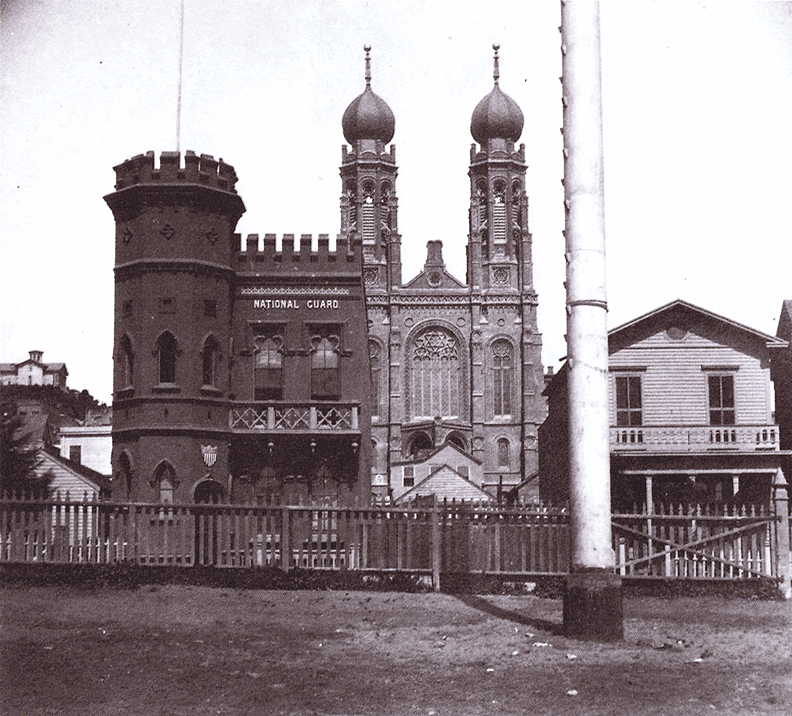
[[0, 495, 790, 585]]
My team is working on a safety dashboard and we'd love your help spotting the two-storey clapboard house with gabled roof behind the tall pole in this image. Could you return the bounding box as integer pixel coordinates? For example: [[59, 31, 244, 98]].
[[539, 300, 789, 510]]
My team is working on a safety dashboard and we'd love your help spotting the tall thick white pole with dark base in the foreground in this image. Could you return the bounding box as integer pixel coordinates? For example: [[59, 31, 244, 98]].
[[561, 0, 624, 641]]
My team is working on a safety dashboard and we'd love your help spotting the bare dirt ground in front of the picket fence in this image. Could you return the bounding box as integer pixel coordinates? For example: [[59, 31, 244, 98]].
[[0, 586, 792, 716]]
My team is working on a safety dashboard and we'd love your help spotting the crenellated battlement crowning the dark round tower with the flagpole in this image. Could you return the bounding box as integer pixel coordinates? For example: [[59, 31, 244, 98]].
[[113, 150, 237, 193]]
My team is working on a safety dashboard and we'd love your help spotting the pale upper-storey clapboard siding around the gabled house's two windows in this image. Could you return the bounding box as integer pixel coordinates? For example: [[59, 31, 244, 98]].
[[609, 330, 772, 426]]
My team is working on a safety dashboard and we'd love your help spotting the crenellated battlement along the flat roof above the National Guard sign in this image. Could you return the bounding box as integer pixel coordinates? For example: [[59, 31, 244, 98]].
[[234, 234, 361, 273]]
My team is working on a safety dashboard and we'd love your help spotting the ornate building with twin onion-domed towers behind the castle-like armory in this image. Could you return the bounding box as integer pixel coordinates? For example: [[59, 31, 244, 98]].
[[340, 46, 545, 499]]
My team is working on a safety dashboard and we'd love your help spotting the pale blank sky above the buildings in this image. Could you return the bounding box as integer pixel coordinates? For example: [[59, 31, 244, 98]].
[[0, 0, 792, 402]]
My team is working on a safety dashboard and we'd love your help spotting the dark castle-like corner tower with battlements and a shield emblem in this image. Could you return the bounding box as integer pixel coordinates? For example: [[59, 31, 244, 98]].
[[105, 151, 245, 502]]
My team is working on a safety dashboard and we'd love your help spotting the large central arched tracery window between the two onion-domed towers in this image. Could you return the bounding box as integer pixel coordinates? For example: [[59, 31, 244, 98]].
[[409, 327, 462, 418]]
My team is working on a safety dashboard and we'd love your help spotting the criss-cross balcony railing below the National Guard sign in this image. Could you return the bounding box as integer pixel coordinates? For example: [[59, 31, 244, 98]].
[[228, 402, 360, 434]]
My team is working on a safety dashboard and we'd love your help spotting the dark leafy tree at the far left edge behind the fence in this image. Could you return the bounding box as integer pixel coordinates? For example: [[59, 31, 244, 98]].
[[0, 396, 52, 498]]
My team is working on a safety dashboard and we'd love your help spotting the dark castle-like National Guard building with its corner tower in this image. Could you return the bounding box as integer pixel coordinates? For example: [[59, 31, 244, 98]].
[[105, 152, 370, 504]]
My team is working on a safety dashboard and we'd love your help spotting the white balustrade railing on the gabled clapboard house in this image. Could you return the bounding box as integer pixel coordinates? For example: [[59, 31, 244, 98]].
[[610, 425, 779, 452]]
